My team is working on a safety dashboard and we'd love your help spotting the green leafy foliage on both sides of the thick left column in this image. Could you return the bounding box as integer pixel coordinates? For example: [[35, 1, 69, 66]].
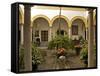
[[19, 44, 42, 70]]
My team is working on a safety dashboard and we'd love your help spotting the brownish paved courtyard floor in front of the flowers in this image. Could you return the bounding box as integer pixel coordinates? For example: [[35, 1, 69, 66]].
[[38, 49, 84, 70]]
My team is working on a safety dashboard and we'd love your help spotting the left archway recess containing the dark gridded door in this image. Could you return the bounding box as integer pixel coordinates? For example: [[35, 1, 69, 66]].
[[32, 16, 49, 47]]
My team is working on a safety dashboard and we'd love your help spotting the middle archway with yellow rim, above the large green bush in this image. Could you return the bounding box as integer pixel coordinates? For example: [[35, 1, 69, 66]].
[[51, 16, 69, 37]]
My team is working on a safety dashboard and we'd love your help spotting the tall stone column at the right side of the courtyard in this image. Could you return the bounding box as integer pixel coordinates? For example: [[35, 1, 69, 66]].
[[88, 8, 94, 67]]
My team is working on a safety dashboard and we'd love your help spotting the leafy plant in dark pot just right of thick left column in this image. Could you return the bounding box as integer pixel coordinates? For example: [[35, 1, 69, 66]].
[[32, 44, 42, 71]]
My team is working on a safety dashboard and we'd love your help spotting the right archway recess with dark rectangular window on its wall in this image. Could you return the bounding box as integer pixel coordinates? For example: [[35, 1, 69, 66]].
[[71, 17, 86, 39]]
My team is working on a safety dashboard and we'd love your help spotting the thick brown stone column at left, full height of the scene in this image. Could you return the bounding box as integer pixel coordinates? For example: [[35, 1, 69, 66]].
[[24, 5, 32, 71]]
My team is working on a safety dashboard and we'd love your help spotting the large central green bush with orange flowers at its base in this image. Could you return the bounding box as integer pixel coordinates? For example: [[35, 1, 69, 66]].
[[48, 35, 74, 58]]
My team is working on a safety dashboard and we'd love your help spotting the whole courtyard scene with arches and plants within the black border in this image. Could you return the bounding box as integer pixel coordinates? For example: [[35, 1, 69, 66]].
[[19, 5, 97, 71]]
